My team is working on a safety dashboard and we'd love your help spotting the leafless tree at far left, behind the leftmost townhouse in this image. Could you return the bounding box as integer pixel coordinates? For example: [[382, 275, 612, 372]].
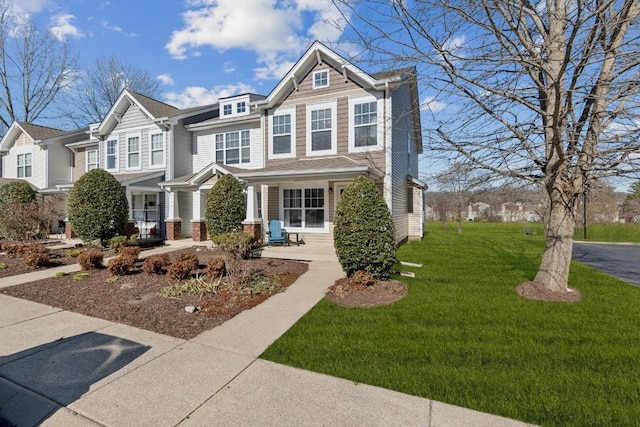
[[0, 0, 77, 133]]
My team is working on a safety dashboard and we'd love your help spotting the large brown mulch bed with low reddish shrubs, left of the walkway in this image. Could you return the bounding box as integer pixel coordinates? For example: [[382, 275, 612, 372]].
[[0, 247, 308, 339]]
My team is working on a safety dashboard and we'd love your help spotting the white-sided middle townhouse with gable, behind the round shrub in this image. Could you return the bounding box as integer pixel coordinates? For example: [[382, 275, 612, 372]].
[[66, 89, 217, 239]]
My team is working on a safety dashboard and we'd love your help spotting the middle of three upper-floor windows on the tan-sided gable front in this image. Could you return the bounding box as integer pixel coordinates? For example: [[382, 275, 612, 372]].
[[307, 102, 337, 155]]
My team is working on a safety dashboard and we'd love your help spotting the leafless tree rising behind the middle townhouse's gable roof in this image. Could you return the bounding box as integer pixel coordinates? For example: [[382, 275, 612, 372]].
[[65, 55, 162, 126]]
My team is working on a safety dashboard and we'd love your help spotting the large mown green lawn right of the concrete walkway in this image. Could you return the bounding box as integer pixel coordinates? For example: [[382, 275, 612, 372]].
[[261, 223, 640, 426]]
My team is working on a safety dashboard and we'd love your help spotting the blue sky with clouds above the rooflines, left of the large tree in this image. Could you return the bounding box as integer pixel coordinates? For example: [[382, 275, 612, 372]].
[[14, 0, 350, 107]]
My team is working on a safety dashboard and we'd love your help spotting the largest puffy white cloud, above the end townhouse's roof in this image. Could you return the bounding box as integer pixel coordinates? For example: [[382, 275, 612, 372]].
[[165, 0, 345, 79]]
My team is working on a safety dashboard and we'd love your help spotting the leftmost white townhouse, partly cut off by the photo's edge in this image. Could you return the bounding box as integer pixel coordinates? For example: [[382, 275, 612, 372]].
[[0, 122, 88, 227]]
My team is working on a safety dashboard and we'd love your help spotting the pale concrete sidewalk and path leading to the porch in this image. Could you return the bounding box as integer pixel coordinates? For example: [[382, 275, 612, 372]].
[[0, 241, 527, 427]]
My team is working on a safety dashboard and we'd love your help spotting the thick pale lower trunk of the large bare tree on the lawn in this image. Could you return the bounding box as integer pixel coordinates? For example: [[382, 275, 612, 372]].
[[534, 186, 576, 292]]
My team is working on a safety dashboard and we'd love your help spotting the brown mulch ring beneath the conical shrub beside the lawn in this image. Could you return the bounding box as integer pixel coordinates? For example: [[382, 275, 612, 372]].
[[325, 278, 407, 307]]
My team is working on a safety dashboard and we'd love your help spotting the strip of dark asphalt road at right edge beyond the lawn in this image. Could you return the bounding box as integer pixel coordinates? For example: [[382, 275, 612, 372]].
[[573, 242, 640, 286]]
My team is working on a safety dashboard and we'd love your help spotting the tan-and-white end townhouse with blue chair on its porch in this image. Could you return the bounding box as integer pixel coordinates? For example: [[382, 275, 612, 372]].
[[165, 42, 425, 246]]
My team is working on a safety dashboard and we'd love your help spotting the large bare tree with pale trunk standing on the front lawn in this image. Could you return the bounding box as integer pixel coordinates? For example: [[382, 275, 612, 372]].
[[334, 0, 640, 292]]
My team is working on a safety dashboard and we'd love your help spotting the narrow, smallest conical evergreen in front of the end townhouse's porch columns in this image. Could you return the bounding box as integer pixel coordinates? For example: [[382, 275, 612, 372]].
[[205, 175, 247, 238]]
